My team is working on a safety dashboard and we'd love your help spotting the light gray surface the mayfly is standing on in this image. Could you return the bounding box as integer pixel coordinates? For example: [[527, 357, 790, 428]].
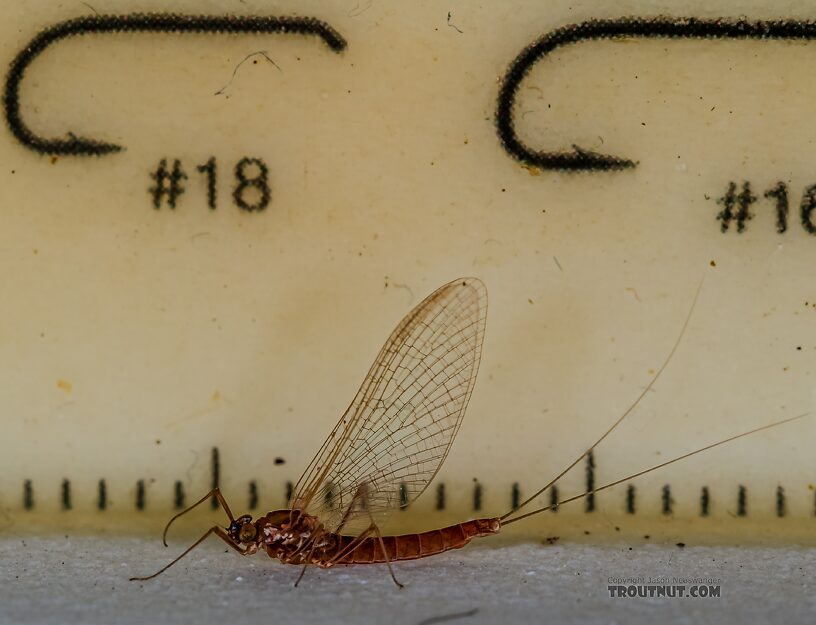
[[0, 536, 816, 625]]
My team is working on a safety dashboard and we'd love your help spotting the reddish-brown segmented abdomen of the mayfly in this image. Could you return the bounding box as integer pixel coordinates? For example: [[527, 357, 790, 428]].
[[335, 519, 501, 564]]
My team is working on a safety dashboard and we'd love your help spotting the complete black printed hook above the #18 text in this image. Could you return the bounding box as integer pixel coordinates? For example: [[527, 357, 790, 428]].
[[3, 13, 347, 156]]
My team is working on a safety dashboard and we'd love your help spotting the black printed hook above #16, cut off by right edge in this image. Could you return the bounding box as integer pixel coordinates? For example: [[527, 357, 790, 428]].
[[496, 17, 816, 171]]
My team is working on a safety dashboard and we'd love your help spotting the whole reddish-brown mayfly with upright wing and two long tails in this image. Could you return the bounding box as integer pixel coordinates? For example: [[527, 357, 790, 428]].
[[132, 278, 805, 587]]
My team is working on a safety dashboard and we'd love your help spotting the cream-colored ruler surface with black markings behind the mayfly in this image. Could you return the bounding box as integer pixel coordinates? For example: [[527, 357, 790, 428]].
[[0, 0, 816, 539]]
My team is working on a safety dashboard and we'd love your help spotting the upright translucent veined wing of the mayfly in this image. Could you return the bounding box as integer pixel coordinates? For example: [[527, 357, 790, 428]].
[[290, 278, 487, 530]]
